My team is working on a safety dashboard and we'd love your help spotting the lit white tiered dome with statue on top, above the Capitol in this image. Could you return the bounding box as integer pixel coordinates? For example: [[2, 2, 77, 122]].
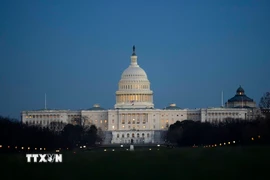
[[115, 46, 154, 109]]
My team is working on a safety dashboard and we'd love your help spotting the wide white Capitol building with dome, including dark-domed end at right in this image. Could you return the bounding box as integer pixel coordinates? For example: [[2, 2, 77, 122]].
[[21, 46, 260, 144]]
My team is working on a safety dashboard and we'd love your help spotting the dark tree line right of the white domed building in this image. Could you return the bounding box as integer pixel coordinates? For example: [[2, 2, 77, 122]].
[[166, 117, 270, 146]]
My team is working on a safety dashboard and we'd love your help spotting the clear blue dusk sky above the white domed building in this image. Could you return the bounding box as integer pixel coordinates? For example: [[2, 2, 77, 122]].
[[0, 0, 270, 118]]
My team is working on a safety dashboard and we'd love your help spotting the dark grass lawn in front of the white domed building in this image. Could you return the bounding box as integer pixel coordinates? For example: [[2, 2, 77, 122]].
[[0, 146, 270, 180]]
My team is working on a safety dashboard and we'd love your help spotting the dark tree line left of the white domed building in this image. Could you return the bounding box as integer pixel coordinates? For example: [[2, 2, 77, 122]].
[[0, 116, 103, 150]]
